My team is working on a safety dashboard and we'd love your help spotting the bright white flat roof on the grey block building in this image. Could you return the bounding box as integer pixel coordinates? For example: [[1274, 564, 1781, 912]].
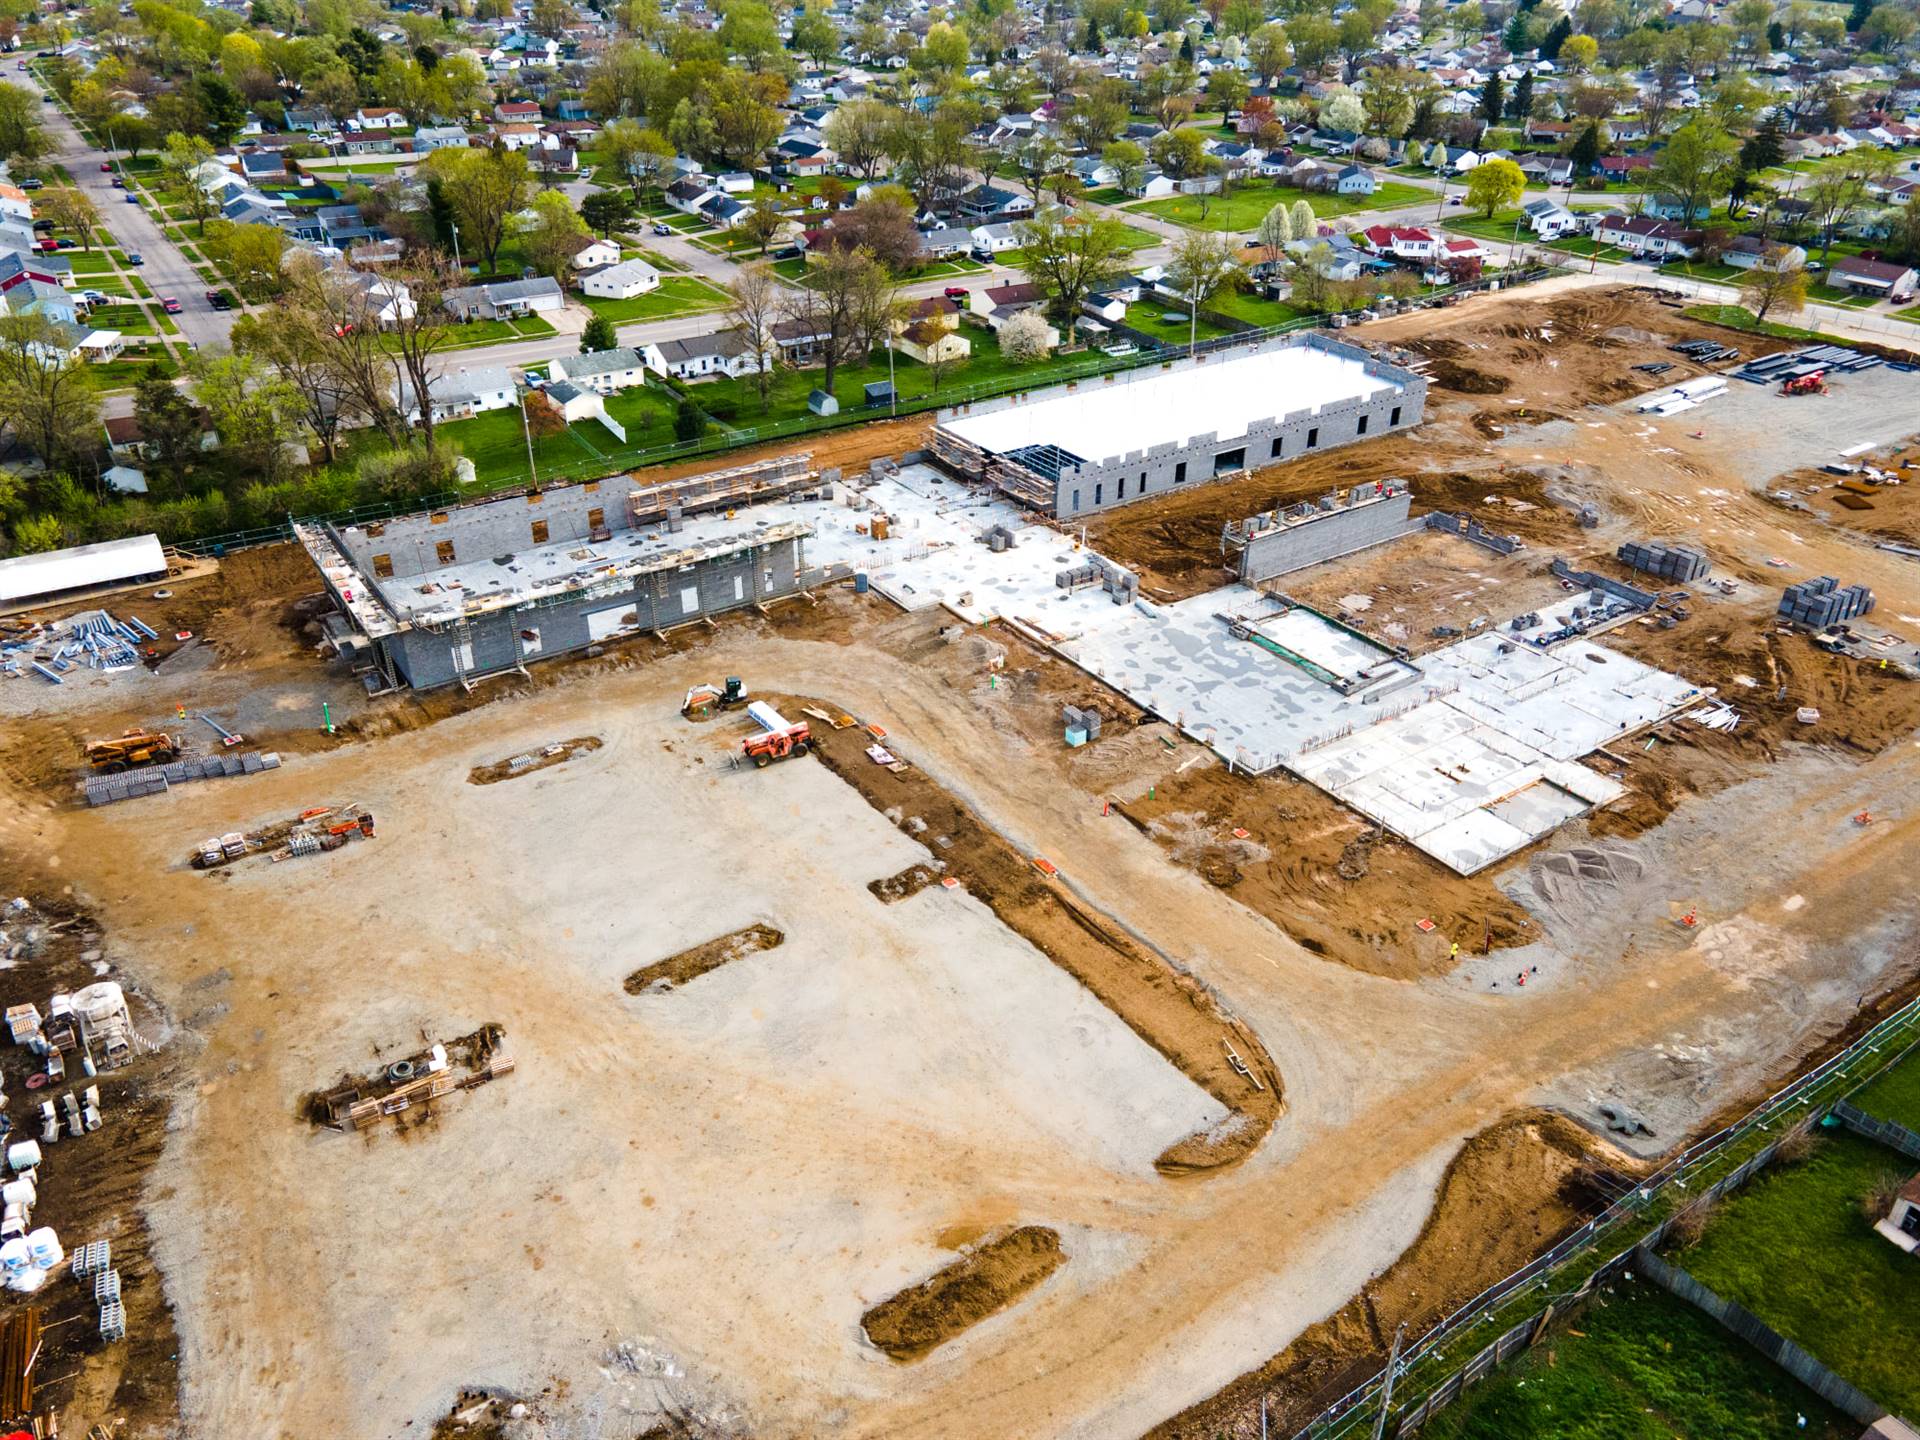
[[943, 346, 1400, 461]]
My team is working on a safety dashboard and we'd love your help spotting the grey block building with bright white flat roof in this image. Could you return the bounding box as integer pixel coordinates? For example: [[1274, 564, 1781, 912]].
[[929, 334, 1427, 520]]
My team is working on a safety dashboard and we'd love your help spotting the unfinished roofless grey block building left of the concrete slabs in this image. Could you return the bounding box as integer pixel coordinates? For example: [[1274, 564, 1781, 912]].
[[294, 453, 818, 693]]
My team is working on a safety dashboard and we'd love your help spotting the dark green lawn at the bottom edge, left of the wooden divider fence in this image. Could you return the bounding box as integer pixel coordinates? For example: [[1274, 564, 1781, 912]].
[[1421, 1281, 1860, 1440]]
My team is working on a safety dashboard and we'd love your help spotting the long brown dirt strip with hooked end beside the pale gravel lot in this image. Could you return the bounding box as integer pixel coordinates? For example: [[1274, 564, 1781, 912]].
[[794, 697, 1284, 1175]]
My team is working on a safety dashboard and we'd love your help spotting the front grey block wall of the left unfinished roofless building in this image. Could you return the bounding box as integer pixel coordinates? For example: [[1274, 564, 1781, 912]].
[[378, 540, 803, 689]]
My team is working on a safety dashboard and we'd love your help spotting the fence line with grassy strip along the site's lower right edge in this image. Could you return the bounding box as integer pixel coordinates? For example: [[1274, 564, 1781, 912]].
[[1294, 998, 1920, 1440]]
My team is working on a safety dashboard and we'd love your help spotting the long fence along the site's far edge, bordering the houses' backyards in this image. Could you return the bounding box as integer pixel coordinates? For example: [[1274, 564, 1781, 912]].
[[173, 267, 1565, 559]]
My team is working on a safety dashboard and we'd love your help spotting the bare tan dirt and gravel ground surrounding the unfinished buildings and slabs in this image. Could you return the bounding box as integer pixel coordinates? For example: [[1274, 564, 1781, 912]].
[[11, 282, 1920, 1440]]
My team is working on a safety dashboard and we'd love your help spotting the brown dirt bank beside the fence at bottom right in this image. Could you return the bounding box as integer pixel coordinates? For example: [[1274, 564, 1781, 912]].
[[1148, 1112, 1632, 1440]]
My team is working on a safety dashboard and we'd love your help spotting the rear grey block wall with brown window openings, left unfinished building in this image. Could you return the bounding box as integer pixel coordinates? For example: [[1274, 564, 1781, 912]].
[[336, 476, 634, 580]]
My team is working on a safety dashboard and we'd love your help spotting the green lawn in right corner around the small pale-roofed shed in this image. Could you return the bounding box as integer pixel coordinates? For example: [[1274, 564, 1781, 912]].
[[1678, 1131, 1920, 1415]]
